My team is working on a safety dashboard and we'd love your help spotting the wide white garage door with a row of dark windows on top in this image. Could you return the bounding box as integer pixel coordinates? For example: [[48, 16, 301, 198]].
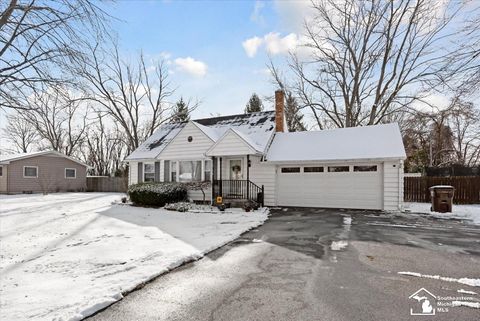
[[277, 164, 383, 209]]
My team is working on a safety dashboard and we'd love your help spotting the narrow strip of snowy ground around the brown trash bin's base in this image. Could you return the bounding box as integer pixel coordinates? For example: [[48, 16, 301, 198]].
[[405, 203, 480, 225]]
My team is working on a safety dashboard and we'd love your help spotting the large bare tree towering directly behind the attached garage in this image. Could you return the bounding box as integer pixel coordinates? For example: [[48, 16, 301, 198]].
[[282, 0, 460, 129]]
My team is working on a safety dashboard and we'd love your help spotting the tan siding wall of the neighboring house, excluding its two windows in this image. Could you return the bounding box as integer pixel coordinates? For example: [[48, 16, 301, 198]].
[[7, 155, 87, 193]]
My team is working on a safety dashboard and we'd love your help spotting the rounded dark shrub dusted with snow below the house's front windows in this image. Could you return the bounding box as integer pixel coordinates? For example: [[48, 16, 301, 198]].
[[128, 183, 187, 207]]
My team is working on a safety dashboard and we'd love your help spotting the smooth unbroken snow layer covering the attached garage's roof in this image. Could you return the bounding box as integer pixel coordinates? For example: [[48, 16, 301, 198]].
[[267, 123, 406, 162]]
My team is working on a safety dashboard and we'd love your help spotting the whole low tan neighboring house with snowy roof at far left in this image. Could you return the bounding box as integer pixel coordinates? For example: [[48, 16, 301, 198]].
[[0, 151, 87, 194]]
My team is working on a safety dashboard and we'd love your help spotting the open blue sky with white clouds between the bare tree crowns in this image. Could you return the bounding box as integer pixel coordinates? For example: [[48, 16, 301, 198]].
[[108, 0, 305, 118]]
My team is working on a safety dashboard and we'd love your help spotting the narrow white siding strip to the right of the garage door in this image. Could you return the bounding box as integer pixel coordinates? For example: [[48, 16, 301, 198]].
[[383, 161, 403, 211]]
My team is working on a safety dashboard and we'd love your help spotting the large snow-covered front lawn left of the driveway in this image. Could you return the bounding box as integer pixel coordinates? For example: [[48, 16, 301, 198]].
[[0, 193, 267, 321]]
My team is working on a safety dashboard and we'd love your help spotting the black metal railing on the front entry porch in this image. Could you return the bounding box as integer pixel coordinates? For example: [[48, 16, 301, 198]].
[[212, 179, 265, 206]]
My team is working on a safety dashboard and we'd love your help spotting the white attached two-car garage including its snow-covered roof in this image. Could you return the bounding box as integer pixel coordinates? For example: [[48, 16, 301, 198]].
[[266, 124, 405, 210]]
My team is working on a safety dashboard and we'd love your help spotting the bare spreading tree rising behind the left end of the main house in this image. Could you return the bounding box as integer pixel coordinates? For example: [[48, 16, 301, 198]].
[[78, 44, 174, 152]]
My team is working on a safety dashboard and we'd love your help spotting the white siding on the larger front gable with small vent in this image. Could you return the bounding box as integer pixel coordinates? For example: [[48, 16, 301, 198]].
[[158, 123, 213, 160]]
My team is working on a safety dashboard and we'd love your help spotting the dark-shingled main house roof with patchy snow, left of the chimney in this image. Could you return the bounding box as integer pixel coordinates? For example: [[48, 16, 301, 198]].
[[126, 110, 275, 161]]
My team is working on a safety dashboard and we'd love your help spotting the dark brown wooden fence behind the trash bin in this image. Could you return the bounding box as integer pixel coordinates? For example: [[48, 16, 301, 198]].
[[404, 176, 480, 204]]
